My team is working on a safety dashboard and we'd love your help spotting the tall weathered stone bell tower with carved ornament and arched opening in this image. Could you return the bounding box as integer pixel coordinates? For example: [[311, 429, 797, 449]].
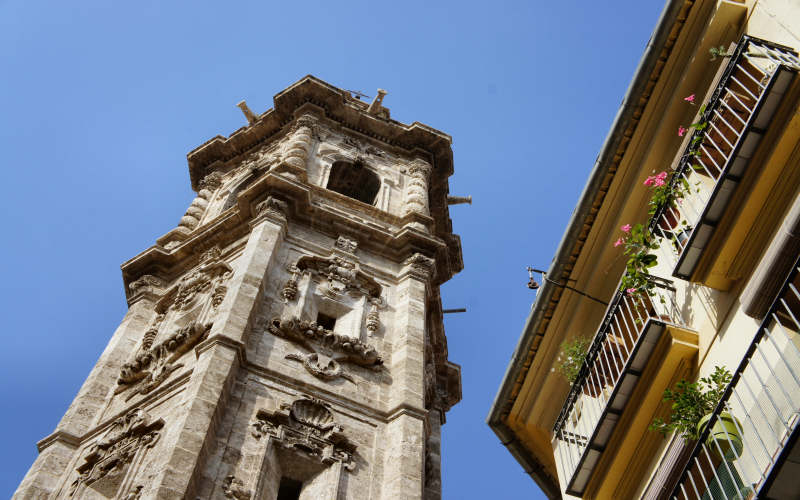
[[15, 76, 463, 500]]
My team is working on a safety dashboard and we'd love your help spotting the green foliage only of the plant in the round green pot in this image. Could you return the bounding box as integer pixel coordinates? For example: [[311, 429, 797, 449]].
[[650, 366, 731, 441]]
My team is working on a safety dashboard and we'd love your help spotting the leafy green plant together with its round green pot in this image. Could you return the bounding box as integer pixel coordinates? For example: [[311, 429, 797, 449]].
[[650, 366, 742, 460]]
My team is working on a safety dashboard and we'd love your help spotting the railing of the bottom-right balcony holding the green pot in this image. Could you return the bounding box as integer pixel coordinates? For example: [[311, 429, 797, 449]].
[[671, 260, 800, 500]]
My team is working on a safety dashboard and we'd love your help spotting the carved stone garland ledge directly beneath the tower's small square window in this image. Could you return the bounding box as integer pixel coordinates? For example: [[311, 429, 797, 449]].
[[267, 318, 383, 370]]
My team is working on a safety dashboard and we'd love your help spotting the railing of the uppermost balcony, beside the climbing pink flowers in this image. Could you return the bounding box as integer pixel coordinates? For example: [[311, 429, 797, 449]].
[[650, 36, 800, 279]]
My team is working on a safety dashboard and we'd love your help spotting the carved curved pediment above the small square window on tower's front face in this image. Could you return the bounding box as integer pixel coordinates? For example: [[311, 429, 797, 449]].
[[295, 256, 381, 297]]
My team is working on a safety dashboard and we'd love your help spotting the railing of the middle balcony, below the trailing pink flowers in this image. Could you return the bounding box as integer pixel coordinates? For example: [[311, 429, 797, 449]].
[[553, 277, 684, 496]]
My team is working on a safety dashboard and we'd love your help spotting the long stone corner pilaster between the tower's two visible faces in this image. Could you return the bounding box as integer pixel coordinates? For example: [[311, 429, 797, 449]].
[[146, 197, 287, 499]]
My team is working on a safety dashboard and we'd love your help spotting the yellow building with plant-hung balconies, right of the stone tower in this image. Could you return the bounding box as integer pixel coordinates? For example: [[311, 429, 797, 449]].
[[488, 0, 800, 499]]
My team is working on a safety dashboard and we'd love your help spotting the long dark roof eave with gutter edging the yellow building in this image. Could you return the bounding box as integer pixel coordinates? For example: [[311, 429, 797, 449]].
[[487, 0, 696, 498]]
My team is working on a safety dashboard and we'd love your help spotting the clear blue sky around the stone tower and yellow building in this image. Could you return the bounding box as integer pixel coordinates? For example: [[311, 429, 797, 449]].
[[0, 0, 663, 499]]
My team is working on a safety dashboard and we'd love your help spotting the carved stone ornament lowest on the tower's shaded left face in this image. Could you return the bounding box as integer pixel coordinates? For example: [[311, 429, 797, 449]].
[[70, 408, 164, 498]]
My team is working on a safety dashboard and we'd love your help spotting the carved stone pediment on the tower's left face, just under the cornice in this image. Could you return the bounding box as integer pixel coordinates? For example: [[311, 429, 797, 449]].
[[156, 247, 233, 312]]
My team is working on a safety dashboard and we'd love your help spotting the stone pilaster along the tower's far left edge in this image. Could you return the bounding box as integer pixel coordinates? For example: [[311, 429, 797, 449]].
[[14, 284, 158, 499]]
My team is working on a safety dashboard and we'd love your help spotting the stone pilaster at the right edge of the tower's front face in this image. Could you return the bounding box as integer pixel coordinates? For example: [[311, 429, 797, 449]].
[[382, 254, 434, 500]]
